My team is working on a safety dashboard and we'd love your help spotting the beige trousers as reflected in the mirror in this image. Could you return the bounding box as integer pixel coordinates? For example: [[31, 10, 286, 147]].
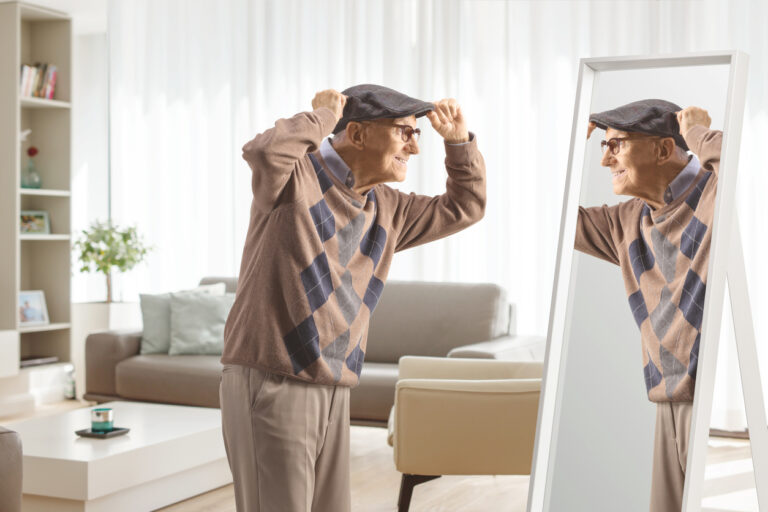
[[651, 402, 693, 512]]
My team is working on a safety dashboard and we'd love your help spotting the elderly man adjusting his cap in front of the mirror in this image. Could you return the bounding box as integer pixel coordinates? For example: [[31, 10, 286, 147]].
[[220, 85, 485, 512]]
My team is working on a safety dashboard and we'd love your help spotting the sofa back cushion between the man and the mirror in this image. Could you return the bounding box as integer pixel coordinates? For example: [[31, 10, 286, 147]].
[[365, 281, 512, 364]]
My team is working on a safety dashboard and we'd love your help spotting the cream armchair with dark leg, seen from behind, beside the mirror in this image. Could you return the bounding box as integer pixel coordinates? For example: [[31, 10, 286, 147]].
[[389, 356, 543, 512]]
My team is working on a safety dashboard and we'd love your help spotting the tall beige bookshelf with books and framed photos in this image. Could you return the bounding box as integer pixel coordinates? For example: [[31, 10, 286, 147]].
[[0, 2, 72, 380]]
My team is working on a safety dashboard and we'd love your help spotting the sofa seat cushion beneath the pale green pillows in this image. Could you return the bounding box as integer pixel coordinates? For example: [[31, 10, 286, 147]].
[[115, 354, 222, 407]]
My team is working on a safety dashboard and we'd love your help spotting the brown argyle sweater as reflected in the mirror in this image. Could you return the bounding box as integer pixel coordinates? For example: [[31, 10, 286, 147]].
[[576, 126, 722, 402]]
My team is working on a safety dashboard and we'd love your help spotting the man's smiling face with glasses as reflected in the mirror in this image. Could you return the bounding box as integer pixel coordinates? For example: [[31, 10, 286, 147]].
[[600, 127, 661, 198]]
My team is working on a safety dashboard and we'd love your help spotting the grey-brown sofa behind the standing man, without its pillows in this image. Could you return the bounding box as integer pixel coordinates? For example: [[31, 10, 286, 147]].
[[84, 277, 545, 426]]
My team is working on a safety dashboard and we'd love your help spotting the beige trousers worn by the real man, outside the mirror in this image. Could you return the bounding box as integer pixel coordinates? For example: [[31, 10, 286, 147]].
[[219, 365, 351, 512]]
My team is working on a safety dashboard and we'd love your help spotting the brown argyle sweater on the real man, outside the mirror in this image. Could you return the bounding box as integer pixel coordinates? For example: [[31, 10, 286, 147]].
[[221, 108, 485, 386]]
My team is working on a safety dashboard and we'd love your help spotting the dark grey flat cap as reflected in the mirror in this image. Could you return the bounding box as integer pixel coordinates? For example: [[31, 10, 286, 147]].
[[589, 100, 688, 151]]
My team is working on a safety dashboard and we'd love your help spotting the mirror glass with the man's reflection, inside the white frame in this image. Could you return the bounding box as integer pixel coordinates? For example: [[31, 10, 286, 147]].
[[547, 65, 729, 511]]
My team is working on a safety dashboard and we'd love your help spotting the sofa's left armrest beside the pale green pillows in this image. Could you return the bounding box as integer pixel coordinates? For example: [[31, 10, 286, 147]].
[[85, 330, 141, 395]]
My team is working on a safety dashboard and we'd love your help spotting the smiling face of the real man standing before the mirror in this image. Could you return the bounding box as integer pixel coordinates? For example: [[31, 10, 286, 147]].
[[363, 116, 419, 183]]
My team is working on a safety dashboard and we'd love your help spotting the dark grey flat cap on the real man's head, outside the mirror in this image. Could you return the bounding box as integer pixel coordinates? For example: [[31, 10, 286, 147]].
[[333, 84, 435, 135]]
